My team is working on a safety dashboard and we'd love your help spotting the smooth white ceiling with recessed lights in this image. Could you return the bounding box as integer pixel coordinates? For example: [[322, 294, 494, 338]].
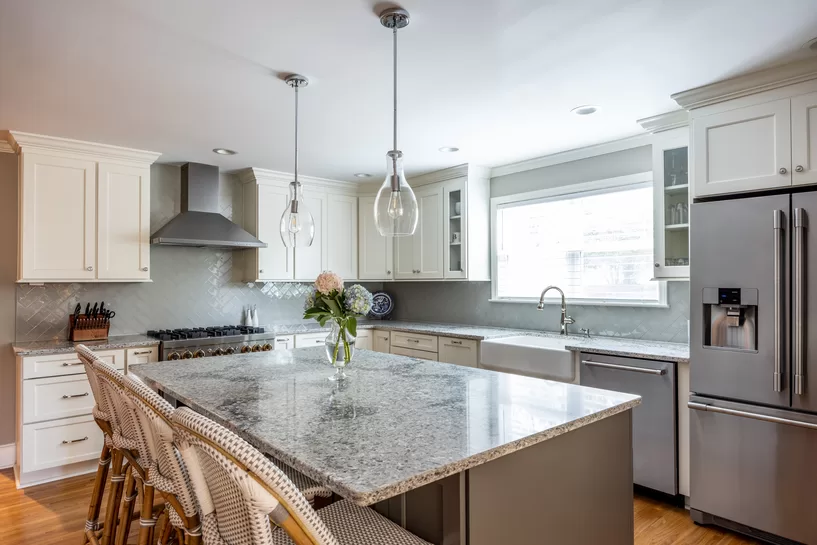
[[0, 0, 817, 180]]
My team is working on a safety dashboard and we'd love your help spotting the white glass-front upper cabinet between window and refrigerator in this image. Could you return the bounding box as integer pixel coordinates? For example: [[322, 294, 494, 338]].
[[652, 127, 690, 280]]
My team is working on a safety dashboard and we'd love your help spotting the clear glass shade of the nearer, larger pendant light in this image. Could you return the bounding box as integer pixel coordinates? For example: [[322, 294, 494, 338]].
[[374, 150, 420, 237]]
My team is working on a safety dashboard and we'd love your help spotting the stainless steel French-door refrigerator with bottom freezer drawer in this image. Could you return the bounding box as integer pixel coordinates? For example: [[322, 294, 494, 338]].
[[689, 192, 817, 544]]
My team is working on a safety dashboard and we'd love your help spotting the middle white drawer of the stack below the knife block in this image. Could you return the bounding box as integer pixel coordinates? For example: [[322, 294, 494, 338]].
[[23, 374, 94, 424]]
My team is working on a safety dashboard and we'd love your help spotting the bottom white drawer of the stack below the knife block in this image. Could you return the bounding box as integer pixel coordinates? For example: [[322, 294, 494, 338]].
[[20, 416, 104, 473]]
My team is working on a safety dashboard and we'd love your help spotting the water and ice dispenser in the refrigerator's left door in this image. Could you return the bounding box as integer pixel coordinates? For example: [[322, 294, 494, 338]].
[[703, 288, 757, 351]]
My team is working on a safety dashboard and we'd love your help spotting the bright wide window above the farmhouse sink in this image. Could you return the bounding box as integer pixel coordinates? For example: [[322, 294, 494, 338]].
[[491, 173, 666, 305]]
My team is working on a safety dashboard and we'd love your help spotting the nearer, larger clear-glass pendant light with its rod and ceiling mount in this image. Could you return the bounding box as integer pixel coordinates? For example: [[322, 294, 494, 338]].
[[374, 8, 420, 237]]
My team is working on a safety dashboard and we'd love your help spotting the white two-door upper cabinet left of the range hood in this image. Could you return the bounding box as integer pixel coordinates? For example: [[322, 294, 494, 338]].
[[10, 131, 159, 282]]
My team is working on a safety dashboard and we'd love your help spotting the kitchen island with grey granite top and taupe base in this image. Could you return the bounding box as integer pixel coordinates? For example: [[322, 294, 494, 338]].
[[133, 347, 640, 545]]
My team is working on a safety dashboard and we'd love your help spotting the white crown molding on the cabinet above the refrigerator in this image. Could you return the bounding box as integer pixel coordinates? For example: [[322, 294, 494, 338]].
[[670, 58, 817, 110]]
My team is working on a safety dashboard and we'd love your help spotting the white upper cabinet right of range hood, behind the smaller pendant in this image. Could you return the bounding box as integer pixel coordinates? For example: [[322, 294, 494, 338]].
[[240, 168, 358, 282]]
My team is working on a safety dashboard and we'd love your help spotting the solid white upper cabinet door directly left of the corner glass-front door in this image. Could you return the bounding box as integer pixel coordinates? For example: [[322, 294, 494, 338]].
[[414, 184, 445, 279]]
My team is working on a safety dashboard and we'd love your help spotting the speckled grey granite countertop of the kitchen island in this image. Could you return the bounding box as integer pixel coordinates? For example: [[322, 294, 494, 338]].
[[133, 347, 641, 505]]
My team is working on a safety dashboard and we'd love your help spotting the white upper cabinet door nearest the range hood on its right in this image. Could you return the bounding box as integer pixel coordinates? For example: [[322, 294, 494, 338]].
[[257, 185, 295, 280]]
